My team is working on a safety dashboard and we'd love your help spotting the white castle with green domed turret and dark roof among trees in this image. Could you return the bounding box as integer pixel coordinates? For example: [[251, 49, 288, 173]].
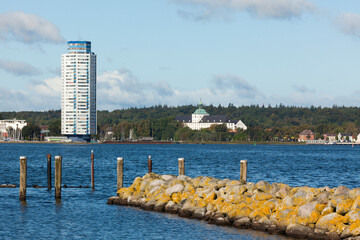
[[176, 103, 247, 131]]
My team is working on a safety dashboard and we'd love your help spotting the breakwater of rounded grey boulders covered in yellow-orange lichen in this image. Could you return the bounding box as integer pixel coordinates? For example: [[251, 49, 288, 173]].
[[108, 173, 360, 240]]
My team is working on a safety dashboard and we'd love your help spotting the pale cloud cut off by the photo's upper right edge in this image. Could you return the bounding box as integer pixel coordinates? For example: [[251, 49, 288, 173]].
[[335, 13, 360, 37]]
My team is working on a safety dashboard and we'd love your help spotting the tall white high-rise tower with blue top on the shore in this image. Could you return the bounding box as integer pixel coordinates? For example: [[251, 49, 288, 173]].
[[61, 41, 97, 141]]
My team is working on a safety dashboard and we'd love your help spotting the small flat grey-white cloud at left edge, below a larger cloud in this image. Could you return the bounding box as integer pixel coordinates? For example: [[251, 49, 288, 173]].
[[0, 60, 40, 76]]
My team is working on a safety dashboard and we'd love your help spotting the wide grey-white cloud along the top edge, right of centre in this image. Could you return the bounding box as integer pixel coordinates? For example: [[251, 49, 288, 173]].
[[170, 0, 315, 20]]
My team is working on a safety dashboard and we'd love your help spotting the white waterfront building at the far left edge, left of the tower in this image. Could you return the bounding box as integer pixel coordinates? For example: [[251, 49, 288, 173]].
[[0, 118, 27, 140]]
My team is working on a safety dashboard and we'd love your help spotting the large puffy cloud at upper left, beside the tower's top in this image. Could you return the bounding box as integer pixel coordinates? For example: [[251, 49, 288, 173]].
[[0, 12, 65, 43]]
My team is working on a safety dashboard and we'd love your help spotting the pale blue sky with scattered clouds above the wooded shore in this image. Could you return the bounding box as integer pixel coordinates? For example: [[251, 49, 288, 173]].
[[0, 0, 360, 111]]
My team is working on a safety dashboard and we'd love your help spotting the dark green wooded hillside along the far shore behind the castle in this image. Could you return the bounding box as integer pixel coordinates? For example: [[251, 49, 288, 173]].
[[0, 104, 360, 141]]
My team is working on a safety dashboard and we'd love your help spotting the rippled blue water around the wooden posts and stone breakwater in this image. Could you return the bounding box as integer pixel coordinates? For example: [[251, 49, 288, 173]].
[[0, 144, 360, 240]]
